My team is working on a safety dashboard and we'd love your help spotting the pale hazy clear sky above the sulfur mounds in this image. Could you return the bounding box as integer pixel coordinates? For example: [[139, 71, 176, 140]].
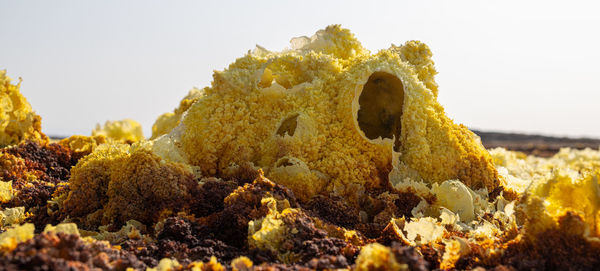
[[0, 0, 600, 137]]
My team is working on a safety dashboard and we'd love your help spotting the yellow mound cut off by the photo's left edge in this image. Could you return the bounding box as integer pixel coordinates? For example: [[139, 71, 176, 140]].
[[0, 70, 48, 148]]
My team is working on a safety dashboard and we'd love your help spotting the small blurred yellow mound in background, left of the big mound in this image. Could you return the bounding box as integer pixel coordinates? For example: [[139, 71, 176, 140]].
[[92, 119, 144, 144]]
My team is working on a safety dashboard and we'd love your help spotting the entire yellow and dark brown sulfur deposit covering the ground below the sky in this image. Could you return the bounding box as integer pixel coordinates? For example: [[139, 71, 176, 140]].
[[0, 25, 600, 270]]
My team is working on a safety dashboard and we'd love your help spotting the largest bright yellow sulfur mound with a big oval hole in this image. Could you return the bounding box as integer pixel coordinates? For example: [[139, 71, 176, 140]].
[[155, 26, 499, 203]]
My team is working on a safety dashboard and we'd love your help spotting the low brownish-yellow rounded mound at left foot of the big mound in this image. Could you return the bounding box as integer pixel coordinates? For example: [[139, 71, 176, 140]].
[[62, 142, 197, 227]]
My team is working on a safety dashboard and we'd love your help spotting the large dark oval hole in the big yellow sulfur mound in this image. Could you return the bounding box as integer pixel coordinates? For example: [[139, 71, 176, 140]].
[[357, 72, 404, 151]]
